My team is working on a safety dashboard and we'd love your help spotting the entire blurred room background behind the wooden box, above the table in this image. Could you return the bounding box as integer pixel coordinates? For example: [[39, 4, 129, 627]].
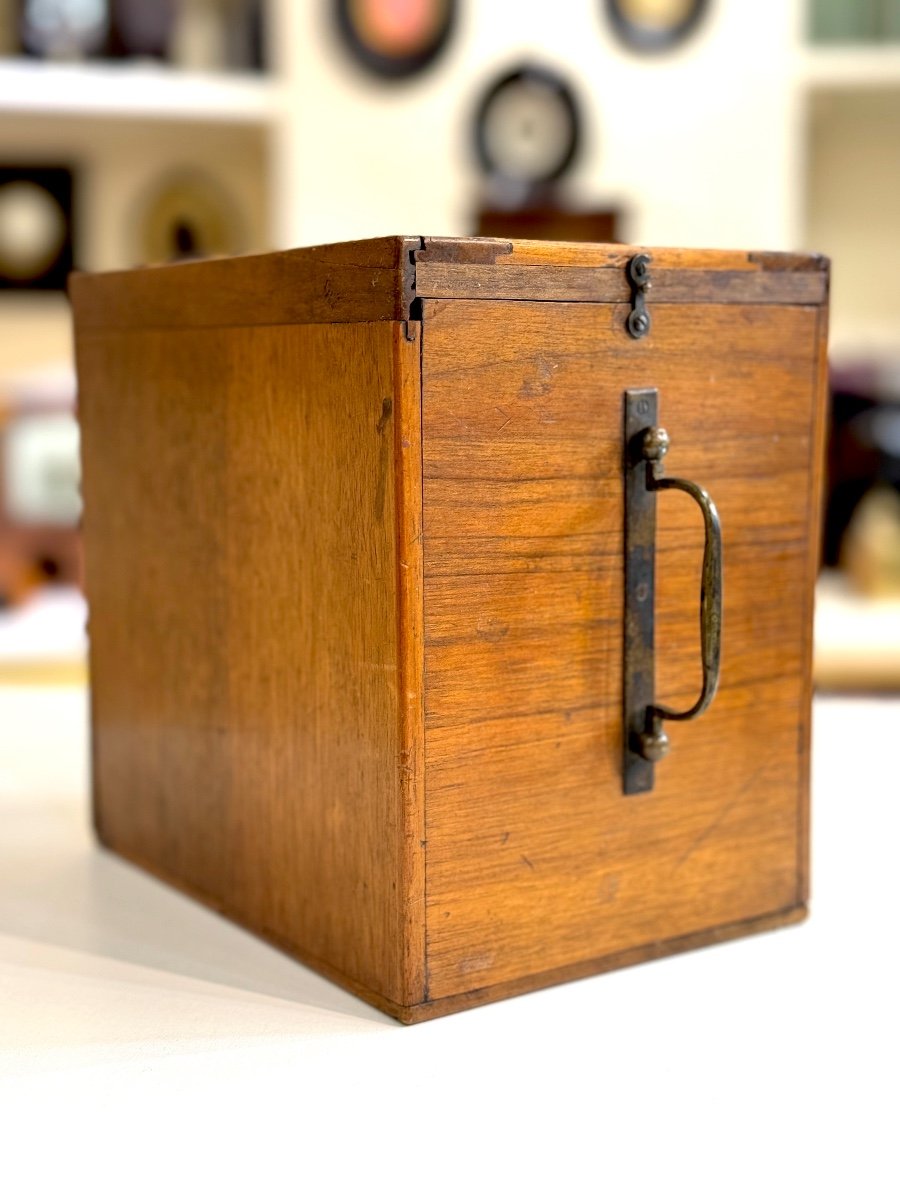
[[0, 0, 900, 690]]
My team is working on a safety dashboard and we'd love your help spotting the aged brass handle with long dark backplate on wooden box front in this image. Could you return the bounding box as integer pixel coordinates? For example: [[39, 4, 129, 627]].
[[624, 388, 722, 793]]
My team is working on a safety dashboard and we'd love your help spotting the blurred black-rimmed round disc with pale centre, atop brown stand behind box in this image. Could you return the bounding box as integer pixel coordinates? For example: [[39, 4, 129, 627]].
[[475, 66, 581, 190]]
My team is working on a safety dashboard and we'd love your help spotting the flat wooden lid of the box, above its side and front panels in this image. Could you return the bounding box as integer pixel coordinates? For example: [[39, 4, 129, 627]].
[[70, 236, 828, 329]]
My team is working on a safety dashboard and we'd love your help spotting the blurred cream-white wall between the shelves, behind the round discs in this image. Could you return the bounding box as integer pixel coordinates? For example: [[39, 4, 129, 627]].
[[274, 0, 800, 248]]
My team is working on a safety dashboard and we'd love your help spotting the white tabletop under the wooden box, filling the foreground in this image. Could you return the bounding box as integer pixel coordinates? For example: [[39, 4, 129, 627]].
[[0, 688, 900, 1200]]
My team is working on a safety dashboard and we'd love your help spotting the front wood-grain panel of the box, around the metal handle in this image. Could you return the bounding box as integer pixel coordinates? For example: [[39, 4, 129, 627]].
[[422, 300, 821, 1000]]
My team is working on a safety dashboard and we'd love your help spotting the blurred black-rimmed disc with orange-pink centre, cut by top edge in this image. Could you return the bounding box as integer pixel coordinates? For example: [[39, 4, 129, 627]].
[[334, 0, 456, 79]]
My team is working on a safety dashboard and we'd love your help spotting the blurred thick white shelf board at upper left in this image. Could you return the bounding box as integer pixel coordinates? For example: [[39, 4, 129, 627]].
[[0, 59, 281, 125]]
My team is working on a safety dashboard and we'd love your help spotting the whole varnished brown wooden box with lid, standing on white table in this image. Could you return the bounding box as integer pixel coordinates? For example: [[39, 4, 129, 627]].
[[71, 238, 828, 1021]]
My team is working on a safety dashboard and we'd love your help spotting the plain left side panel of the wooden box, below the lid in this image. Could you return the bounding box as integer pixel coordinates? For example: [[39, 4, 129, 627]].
[[77, 312, 421, 1004]]
